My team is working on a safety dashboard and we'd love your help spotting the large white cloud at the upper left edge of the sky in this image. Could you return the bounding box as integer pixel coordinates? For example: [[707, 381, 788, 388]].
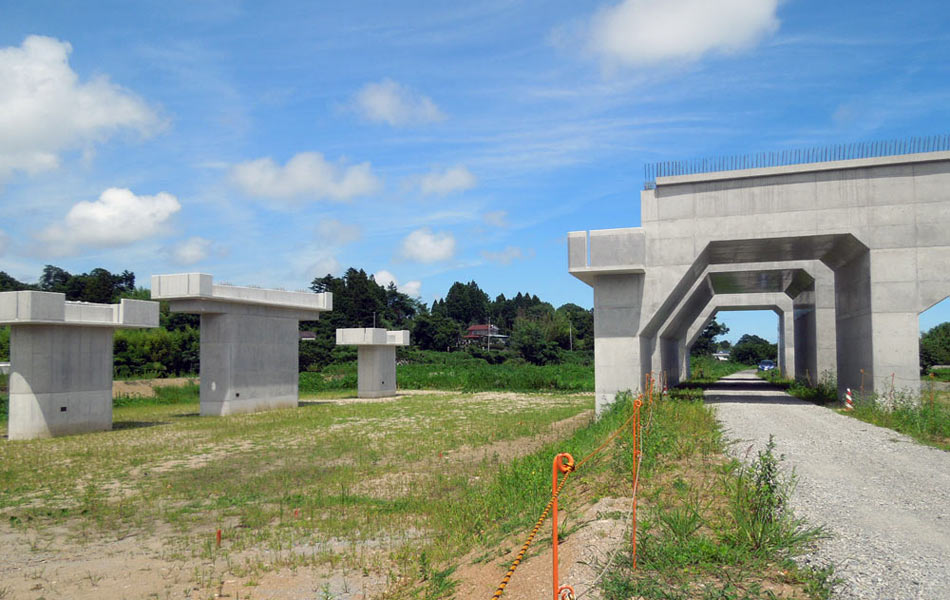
[[0, 35, 162, 181]]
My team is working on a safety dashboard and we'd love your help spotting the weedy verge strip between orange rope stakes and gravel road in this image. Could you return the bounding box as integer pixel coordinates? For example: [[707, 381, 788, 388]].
[[599, 404, 835, 600]]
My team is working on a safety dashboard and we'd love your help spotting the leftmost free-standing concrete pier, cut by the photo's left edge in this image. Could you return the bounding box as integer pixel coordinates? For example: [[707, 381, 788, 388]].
[[0, 291, 158, 440]]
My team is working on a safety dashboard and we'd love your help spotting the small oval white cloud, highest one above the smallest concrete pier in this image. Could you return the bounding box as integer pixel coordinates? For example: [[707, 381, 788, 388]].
[[353, 78, 445, 127]]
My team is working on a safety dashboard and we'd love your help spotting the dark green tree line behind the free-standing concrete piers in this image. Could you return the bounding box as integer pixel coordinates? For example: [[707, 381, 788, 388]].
[[0, 265, 594, 377]]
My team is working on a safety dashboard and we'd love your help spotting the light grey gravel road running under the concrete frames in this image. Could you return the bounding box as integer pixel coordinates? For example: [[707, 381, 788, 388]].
[[706, 371, 950, 600]]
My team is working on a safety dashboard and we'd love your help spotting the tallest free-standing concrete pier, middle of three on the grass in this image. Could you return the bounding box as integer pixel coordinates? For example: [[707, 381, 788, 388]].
[[152, 273, 333, 416]]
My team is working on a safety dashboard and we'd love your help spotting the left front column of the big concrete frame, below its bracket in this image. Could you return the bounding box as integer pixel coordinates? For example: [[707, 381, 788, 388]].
[[593, 274, 643, 414]]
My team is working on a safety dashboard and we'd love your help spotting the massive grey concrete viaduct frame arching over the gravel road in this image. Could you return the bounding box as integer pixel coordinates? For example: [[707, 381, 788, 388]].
[[568, 152, 950, 410]]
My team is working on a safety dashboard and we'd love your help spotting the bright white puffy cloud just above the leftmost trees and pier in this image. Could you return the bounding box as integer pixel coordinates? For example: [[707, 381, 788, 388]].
[[37, 188, 181, 255]]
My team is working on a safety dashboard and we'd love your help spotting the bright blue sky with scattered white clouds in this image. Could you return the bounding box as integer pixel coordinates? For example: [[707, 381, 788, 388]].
[[0, 0, 950, 339]]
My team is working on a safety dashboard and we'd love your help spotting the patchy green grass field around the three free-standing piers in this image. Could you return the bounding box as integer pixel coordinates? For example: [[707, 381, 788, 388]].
[[0, 386, 593, 597]]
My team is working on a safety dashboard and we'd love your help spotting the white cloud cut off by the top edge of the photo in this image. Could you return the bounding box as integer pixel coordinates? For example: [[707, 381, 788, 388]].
[[589, 0, 779, 66]]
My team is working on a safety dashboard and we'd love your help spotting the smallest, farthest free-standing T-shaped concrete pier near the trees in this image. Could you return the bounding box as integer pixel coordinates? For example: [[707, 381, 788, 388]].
[[336, 328, 409, 398]]
